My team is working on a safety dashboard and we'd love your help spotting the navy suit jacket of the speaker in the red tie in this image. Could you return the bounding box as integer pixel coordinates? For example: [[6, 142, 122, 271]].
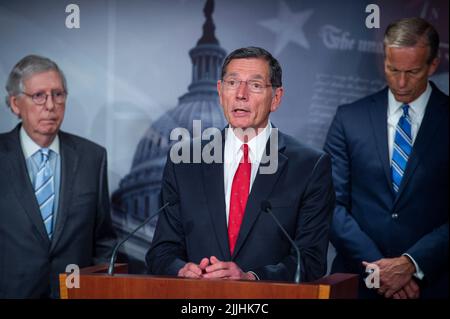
[[147, 132, 335, 281]]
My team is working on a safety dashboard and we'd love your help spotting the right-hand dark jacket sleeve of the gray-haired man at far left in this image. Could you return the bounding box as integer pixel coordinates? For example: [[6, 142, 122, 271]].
[[94, 150, 116, 264]]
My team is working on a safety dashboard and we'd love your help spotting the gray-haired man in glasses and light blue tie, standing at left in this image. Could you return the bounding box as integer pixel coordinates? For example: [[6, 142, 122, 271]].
[[0, 55, 115, 298]]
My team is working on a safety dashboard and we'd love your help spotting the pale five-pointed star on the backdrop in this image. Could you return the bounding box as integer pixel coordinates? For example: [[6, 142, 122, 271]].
[[259, 1, 314, 55]]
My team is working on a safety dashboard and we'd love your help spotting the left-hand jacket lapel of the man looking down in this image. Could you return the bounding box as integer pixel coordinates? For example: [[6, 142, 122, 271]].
[[369, 89, 394, 195]]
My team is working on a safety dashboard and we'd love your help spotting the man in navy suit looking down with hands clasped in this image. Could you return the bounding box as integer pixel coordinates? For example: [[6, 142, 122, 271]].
[[325, 18, 449, 298]]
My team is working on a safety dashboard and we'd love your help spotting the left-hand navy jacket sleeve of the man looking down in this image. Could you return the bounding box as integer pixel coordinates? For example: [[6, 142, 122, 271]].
[[324, 109, 383, 266]]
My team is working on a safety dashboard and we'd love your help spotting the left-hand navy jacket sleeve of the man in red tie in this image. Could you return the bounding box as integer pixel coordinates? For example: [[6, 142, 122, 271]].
[[146, 157, 186, 276]]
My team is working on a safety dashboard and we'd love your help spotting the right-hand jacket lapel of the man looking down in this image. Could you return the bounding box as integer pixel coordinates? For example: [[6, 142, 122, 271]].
[[394, 87, 448, 206]]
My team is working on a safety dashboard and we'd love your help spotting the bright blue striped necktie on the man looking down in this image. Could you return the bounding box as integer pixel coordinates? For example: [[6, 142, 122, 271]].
[[391, 104, 412, 193]]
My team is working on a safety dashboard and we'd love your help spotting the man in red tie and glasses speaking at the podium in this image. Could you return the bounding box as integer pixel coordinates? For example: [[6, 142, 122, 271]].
[[147, 47, 334, 281]]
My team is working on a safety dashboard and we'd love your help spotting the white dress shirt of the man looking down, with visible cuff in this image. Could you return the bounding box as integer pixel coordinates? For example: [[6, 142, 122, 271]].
[[387, 83, 432, 279]]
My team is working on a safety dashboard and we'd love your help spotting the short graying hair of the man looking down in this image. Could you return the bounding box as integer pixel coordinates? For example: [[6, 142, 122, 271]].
[[383, 17, 439, 64]]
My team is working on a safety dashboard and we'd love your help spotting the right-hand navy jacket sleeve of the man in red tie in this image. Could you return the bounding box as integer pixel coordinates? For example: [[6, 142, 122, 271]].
[[252, 154, 335, 282]]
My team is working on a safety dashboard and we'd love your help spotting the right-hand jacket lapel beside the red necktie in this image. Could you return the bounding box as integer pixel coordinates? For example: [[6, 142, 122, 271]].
[[233, 128, 288, 258]]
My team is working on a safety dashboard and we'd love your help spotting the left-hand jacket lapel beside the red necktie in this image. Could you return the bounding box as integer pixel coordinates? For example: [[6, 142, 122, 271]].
[[202, 131, 231, 260]]
